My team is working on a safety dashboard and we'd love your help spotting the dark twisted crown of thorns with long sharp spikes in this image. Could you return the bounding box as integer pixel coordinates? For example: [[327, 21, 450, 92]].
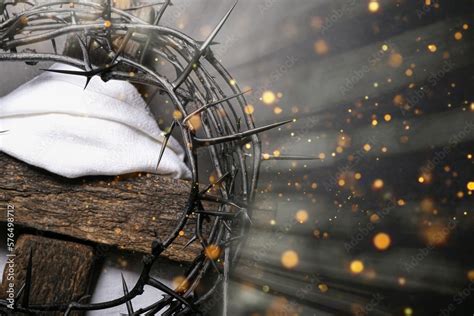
[[0, 0, 310, 315]]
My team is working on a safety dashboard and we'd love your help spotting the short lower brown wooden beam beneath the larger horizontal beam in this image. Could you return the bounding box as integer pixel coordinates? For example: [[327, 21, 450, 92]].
[[1, 235, 95, 315]]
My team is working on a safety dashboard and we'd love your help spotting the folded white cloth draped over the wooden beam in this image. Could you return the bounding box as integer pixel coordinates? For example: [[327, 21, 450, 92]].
[[0, 64, 190, 178]]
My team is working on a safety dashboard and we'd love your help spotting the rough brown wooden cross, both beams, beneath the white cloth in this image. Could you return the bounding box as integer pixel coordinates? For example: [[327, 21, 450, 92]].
[[0, 153, 201, 312]]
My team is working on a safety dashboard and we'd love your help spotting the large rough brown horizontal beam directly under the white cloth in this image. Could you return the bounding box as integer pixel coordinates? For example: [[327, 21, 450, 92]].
[[0, 153, 200, 262]]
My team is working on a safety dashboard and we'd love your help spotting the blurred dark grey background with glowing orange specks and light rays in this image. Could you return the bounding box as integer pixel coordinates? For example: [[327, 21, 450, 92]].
[[0, 0, 474, 316]]
